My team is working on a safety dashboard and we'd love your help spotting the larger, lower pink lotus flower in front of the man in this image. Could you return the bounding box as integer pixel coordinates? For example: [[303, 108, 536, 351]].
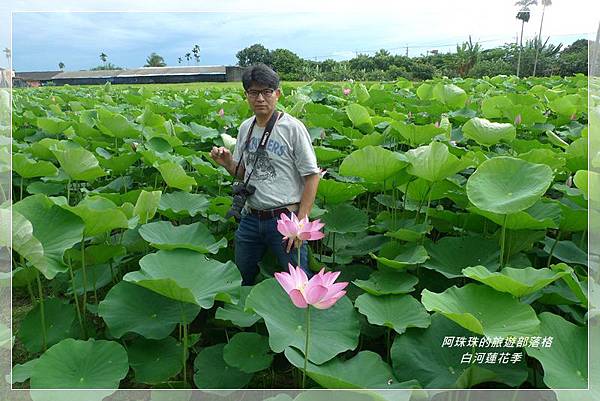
[[275, 264, 348, 309]]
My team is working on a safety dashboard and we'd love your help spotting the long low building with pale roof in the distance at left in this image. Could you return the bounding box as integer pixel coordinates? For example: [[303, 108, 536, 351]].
[[17, 66, 243, 86]]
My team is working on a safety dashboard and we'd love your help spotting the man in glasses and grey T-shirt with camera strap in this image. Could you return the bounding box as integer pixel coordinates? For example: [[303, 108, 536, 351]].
[[211, 64, 320, 285]]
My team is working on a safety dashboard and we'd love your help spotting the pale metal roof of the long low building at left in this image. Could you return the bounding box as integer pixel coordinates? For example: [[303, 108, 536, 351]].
[[54, 66, 226, 79]]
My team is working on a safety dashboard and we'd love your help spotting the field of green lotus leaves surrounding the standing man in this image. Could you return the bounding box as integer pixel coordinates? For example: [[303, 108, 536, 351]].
[[5, 76, 589, 389]]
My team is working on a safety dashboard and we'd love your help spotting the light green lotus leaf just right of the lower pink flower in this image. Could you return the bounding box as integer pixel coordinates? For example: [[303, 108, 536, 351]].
[[354, 294, 430, 334]]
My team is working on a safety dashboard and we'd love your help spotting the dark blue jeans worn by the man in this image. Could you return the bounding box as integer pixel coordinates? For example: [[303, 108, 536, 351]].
[[235, 209, 312, 285]]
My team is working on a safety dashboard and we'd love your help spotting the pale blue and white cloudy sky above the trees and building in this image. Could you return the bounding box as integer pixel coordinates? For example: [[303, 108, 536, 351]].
[[0, 0, 600, 71]]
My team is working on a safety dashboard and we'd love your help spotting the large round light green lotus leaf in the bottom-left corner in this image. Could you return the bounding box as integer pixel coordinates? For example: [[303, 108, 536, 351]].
[[31, 338, 129, 389]]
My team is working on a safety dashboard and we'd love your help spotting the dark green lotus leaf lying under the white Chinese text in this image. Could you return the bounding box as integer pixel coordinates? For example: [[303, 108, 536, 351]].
[[391, 313, 527, 388]]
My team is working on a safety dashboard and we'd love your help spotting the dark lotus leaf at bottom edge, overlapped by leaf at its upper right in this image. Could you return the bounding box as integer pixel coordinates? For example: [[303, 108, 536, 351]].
[[194, 344, 252, 389]]
